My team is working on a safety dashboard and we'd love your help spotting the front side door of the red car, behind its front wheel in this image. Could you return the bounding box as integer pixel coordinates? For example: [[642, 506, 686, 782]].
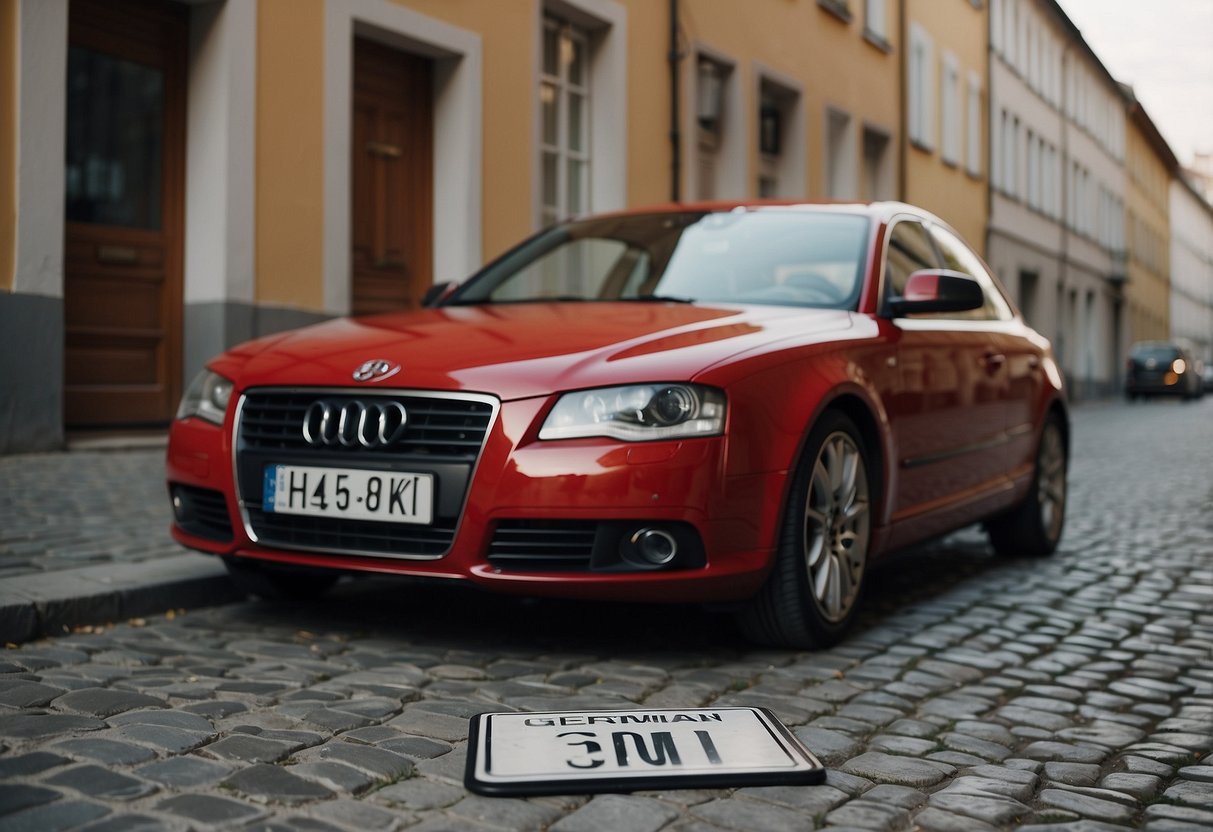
[[884, 217, 1006, 537]]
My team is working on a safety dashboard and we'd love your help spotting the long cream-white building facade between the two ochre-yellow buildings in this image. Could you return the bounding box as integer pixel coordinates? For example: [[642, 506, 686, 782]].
[[986, 0, 1128, 399]]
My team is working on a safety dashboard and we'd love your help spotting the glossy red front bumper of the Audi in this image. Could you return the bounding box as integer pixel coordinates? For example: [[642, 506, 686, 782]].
[[167, 388, 785, 602]]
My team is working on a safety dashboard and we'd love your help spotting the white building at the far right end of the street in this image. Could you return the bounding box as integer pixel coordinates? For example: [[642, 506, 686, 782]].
[[1171, 179, 1213, 364]]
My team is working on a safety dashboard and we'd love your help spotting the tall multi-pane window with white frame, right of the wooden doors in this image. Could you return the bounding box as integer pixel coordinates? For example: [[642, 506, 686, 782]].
[[539, 15, 591, 226]]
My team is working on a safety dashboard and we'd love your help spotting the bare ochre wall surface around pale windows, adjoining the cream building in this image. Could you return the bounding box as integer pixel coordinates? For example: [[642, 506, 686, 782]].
[[902, 0, 990, 253]]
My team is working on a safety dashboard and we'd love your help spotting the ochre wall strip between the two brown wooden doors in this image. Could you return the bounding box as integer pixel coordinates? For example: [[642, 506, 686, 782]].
[[255, 0, 324, 312]]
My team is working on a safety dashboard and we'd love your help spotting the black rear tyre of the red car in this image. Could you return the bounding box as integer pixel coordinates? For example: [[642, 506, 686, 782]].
[[985, 414, 1069, 558]]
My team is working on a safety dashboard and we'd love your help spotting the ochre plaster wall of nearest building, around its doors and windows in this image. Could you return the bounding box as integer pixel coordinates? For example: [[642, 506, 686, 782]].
[[246, 0, 907, 312]]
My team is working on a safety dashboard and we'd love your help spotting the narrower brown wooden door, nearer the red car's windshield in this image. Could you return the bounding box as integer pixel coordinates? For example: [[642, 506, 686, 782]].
[[351, 38, 434, 314]]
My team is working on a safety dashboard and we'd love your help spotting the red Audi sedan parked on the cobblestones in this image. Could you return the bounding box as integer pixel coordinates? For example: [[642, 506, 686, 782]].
[[167, 203, 1069, 646]]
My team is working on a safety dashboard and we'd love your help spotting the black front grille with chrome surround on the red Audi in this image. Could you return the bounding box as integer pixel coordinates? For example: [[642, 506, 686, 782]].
[[235, 388, 497, 559]]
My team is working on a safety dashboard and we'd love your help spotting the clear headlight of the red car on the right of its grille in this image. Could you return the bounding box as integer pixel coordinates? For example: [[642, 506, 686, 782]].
[[539, 384, 724, 441]]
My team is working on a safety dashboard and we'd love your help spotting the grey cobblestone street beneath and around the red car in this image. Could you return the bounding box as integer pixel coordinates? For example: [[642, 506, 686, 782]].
[[0, 399, 1213, 832]]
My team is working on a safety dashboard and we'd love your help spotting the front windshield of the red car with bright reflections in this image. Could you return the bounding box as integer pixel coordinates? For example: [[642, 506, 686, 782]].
[[449, 210, 867, 309]]
